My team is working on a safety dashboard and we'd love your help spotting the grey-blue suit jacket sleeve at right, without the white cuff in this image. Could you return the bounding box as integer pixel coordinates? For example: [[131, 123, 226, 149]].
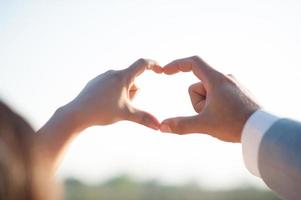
[[258, 118, 301, 200]]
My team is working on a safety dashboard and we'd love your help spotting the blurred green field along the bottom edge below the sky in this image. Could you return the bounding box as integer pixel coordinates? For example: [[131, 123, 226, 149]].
[[64, 175, 279, 200]]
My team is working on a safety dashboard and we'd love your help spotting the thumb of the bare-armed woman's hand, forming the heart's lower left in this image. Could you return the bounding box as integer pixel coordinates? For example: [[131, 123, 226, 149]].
[[127, 106, 160, 130]]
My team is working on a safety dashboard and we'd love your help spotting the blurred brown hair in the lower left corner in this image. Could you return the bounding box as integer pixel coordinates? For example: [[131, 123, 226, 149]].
[[0, 101, 55, 200]]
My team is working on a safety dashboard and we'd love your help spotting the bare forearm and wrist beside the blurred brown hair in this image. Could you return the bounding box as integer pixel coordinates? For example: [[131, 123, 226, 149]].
[[36, 106, 82, 169]]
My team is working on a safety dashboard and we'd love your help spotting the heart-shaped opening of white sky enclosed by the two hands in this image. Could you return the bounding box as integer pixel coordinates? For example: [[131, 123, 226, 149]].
[[133, 71, 197, 121]]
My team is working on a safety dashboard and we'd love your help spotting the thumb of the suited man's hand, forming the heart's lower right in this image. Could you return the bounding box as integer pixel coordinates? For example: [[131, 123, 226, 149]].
[[160, 115, 201, 134]]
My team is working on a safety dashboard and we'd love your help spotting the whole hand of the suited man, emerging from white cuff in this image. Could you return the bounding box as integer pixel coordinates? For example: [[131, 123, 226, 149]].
[[160, 56, 260, 142]]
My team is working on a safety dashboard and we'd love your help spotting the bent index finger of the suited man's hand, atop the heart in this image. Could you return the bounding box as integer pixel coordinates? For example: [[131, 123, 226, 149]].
[[163, 56, 219, 84]]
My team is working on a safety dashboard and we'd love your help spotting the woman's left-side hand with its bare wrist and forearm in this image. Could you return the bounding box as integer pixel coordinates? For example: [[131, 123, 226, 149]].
[[35, 59, 163, 170]]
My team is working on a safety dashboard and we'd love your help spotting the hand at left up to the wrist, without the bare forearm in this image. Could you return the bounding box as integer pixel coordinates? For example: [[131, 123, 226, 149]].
[[64, 59, 163, 130]]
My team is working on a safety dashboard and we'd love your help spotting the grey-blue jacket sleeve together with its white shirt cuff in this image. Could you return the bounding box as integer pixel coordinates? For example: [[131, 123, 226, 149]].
[[242, 111, 301, 200]]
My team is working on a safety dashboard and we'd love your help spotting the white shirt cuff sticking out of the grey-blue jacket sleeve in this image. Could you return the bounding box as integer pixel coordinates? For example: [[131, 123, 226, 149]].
[[241, 110, 279, 177]]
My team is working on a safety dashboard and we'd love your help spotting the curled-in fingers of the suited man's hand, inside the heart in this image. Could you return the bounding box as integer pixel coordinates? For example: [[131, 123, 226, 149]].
[[188, 82, 206, 113]]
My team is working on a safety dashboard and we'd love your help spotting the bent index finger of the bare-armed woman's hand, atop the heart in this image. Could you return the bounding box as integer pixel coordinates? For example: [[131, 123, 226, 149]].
[[127, 58, 163, 80]]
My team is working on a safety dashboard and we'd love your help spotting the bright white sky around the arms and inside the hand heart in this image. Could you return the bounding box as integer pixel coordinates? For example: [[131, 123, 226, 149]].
[[0, 0, 301, 189]]
